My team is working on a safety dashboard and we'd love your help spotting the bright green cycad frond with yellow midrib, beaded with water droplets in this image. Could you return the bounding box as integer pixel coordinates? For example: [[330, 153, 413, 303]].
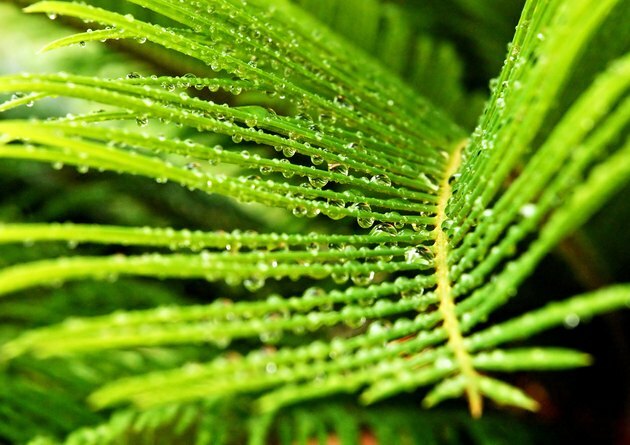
[[0, 0, 630, 442]]
